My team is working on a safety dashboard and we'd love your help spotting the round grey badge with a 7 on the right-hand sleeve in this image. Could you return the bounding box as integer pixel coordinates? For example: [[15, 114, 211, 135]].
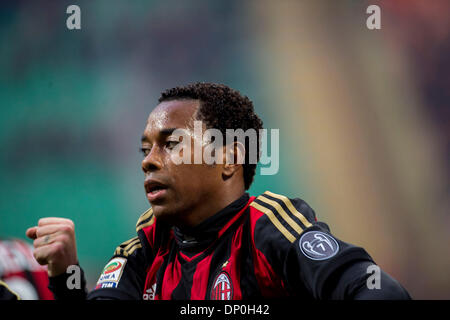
[[299, 231, 339, 260]]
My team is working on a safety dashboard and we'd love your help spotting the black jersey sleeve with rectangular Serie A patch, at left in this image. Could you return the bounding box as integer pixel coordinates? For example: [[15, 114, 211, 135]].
[[88, 211, 154, 300]]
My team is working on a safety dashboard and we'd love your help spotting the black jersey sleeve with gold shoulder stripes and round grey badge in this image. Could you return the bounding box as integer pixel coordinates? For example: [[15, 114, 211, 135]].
[[252, 191, 373, 299]]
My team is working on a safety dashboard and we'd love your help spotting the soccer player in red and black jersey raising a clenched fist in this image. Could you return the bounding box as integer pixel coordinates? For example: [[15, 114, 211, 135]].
[[27, 83, 410, 300]]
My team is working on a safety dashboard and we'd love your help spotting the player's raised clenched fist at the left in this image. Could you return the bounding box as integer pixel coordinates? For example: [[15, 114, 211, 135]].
[[26, 218, 78, 277]]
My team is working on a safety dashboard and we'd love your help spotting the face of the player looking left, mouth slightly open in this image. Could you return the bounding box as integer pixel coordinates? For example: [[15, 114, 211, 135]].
[[142, 100, 222, 225]]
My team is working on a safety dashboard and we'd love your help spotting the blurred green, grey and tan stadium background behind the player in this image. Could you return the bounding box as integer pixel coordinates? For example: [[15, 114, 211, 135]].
[[0, 0, 450, 299]]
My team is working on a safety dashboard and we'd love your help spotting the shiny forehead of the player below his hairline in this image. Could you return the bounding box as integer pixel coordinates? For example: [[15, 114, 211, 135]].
[[144, 100, 200, 135]]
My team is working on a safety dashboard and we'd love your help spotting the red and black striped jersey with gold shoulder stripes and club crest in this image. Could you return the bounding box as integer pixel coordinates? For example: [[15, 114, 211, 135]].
[[88, 191, 373, 300]]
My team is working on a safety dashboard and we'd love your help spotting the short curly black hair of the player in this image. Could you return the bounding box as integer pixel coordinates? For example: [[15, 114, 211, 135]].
[[159, 82, 263, 190]]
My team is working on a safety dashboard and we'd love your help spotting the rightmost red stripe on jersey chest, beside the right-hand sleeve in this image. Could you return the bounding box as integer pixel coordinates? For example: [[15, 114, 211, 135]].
[[250, 207, 286, 298]]
